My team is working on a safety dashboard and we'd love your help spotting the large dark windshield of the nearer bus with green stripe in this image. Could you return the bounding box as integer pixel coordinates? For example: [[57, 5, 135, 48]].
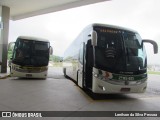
[[95, 28, 147, 72]]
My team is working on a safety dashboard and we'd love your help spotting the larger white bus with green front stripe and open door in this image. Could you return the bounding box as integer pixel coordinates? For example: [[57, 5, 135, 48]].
[[63, 23, 158, 94]]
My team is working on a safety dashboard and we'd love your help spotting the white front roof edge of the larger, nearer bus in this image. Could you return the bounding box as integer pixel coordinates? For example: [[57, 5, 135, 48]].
[[87, 23, 138, 33]]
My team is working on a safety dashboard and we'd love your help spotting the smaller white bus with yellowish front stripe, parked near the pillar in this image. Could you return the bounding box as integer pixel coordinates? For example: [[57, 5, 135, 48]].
[[9, 36, 53, 79]]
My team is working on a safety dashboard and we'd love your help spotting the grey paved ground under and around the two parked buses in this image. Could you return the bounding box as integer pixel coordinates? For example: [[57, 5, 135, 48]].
[[0, 67, 160, 120]]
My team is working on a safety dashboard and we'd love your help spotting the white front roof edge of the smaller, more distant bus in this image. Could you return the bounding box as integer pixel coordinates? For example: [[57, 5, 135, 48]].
[[17, 36, 49, 42]]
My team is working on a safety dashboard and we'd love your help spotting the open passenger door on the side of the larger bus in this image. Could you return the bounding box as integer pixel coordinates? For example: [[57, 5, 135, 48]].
[[77, 43, 85, 88]]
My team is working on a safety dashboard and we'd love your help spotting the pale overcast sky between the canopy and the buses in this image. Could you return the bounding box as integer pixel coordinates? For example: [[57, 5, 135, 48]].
[[9, 0, 160, 65]]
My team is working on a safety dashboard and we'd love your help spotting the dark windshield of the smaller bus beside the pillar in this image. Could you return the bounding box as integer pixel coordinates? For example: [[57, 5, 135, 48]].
[[13, 39, 49, 67]]
